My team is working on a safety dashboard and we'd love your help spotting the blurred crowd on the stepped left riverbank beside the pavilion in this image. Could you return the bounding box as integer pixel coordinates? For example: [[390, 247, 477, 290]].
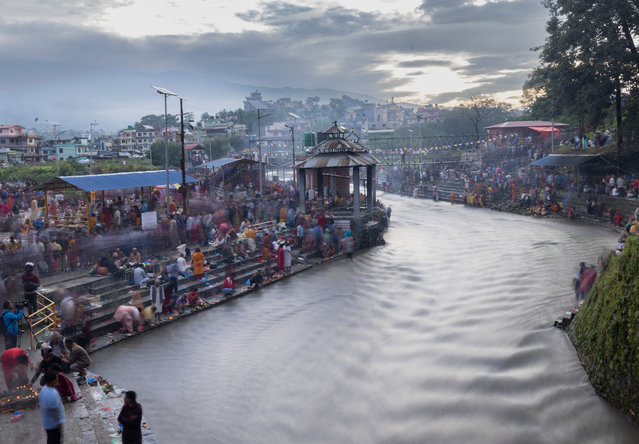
[[0, 175, 364, 338]]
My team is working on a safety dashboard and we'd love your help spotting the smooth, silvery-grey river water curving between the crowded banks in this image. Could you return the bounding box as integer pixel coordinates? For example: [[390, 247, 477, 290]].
[[93, 194, 639, 444]]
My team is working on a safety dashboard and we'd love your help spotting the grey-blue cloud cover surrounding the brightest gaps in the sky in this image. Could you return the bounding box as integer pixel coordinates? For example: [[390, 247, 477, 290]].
[[0, 0, 545, 128]]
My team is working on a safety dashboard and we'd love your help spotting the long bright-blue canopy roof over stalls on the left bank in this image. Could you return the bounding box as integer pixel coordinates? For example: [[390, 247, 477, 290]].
[[34, 170, 198, 191]]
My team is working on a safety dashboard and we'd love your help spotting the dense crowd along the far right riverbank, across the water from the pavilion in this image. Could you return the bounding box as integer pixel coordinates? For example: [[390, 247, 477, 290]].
[[380, 136, 639, 227]]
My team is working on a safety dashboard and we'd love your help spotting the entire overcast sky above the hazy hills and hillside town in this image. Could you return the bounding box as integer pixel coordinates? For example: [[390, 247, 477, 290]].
[[0, 0, 547, 129]]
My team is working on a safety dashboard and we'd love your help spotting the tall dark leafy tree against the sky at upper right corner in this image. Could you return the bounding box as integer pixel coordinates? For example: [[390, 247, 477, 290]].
[[524, 0, 639, 147]]
